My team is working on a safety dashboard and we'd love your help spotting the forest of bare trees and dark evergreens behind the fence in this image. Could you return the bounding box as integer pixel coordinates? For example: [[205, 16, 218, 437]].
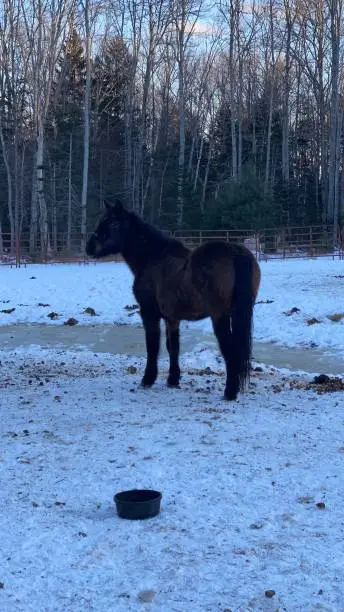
[[0, 0, 344, 255]]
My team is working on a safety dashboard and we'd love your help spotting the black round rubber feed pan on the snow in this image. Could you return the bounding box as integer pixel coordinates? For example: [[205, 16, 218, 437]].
[[114, 489, 162, 520]]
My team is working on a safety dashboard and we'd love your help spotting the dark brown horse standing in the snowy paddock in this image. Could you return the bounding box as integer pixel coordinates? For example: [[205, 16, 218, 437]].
[[86, 201, 260, 400]]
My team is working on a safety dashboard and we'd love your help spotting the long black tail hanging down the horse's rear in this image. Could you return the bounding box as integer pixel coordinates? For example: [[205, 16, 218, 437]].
[[231, 254, 256, 391]]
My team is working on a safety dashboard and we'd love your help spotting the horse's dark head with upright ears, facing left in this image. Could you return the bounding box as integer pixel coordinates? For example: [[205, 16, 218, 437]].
[[86, 200, 130, 259]]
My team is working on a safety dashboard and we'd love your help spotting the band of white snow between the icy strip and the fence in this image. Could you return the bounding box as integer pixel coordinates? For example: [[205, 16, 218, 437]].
[[0, 258, 344, 356]]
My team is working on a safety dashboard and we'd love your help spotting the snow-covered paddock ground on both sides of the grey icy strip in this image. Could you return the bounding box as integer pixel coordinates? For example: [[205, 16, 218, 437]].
[[0, 260, 344, 612]]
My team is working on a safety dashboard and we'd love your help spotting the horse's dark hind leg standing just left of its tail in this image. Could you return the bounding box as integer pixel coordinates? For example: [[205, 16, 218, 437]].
[[212, 314, 240, 400]]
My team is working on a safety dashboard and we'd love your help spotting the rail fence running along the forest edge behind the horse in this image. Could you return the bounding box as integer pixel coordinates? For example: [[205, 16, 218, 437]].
[[0, 225, 344, 266]]
